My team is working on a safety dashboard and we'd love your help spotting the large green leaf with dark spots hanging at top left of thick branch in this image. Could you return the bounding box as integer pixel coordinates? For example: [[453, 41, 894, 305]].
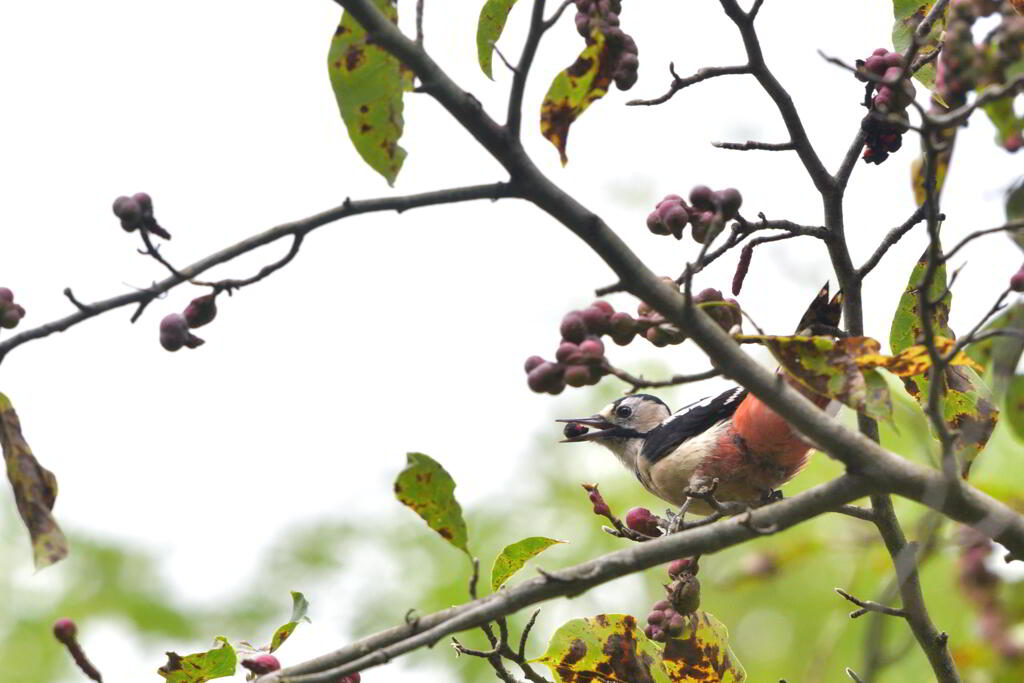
[[328, 0, 412, 185]]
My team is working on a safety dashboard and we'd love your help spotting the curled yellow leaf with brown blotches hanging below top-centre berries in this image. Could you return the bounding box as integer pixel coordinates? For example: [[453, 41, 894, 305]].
[[541, 29, 617, 166]]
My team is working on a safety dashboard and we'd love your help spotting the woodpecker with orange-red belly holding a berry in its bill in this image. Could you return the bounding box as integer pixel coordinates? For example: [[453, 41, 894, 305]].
[[558, 285, 842, 515]]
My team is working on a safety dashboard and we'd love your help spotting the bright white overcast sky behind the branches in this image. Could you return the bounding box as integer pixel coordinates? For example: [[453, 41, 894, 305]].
[[0, 0, 1021, 680]]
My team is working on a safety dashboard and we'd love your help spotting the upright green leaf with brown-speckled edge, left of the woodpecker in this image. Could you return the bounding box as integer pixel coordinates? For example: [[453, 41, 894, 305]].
[[394, 453, 469, 555]]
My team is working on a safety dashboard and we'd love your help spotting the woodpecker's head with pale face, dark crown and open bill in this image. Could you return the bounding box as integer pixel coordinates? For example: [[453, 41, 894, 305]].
[[558, 393, 672, 459]]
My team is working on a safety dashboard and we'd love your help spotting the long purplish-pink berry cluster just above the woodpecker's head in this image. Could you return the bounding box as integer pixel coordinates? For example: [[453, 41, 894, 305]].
[[524, 286, 741, 393]]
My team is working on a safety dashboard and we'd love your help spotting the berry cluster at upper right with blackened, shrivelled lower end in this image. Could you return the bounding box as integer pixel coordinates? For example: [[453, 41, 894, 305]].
[[857, 47, 916, 164]]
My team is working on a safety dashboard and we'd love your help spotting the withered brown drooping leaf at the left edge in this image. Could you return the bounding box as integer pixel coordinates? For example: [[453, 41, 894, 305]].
[[0, 393, 68, 569]]
